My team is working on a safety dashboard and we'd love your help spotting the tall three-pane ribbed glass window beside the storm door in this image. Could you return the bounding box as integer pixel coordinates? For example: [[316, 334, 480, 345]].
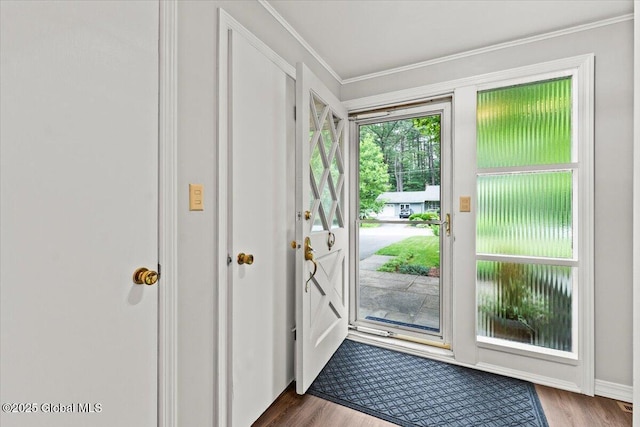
[[476, 76, 580, 352]]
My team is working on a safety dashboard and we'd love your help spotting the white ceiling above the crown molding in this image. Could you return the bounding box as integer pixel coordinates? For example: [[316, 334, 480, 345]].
[[263, 0, 633, 80]]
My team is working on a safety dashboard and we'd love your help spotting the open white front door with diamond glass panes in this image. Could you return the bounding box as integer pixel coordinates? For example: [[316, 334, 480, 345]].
[[296, 64, 349, 394]]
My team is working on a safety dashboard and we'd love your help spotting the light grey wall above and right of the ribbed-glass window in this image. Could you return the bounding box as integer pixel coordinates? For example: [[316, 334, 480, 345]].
[[341, 21, 633, 392]]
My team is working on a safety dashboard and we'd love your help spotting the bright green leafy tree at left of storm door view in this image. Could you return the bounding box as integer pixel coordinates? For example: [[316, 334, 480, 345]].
[[360, 135, 389, 218]]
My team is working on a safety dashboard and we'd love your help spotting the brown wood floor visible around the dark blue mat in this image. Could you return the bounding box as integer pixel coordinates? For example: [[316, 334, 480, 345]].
[[253, 385, 632, 427]]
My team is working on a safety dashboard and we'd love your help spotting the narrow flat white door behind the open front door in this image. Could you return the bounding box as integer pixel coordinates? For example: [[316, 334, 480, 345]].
[[227, 31, 295, 427]]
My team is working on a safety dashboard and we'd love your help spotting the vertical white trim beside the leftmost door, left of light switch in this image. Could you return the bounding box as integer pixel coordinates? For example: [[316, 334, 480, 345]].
[[157, 0, 178, 427]]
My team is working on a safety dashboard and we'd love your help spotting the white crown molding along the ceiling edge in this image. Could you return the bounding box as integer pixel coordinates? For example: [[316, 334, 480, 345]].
[[258, 0, 633, 85]]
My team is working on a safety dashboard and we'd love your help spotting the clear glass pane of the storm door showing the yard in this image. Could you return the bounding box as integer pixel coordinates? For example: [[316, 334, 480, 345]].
[[355, 104, 450, 337]]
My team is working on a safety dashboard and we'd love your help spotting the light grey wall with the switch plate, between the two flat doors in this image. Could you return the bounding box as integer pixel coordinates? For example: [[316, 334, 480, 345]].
[[172, 1, 340, 426]]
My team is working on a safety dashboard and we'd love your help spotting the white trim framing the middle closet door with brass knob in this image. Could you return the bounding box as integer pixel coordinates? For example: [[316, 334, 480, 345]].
[[215, 10, 296, 426]]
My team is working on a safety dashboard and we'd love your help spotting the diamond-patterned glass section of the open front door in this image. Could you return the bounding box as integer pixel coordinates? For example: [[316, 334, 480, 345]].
[[309, 93, 345, 230]]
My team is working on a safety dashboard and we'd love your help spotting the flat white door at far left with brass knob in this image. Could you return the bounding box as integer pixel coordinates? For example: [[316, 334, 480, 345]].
[[0, 0, 158, 427]]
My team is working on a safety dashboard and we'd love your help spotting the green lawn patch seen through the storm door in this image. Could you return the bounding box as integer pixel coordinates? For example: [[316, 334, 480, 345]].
[[376, 236, 440, 271]]
